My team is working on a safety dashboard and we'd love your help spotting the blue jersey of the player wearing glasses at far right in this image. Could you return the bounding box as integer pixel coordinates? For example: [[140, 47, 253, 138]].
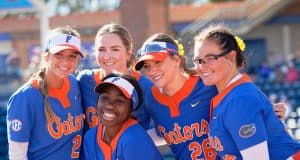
[[210, 75, 300, 160]]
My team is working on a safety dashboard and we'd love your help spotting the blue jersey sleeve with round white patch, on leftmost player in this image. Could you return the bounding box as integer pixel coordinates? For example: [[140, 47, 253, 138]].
[[7, 92, 34, 142]]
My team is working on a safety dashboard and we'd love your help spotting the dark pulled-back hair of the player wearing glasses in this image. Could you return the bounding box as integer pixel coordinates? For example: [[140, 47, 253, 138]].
[[194, 24, 246, 68]]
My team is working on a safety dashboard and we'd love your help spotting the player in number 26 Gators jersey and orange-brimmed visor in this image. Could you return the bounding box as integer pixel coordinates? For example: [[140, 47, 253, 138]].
[[135, 34, 217, 160]]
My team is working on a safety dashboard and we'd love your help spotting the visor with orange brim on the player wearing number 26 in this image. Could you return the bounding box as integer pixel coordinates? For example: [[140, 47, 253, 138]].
[[135, 41, 178, 70]]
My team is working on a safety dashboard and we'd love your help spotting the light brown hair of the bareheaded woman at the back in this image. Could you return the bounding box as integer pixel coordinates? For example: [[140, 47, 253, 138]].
[[95, 23, 134, 68]]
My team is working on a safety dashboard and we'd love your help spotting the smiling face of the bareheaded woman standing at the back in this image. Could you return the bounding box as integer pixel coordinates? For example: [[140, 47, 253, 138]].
[[95, 33, 130, 74]]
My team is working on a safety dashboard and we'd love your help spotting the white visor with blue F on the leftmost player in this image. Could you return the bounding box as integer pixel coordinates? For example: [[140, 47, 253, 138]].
[[46, 33, 85, 58]]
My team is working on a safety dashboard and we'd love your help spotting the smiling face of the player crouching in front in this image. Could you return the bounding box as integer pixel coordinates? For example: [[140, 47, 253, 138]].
[[97, 85, 132, 131]]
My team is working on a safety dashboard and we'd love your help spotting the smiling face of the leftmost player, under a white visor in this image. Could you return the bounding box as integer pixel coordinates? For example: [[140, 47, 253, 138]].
[[45, 49, 80, 79]]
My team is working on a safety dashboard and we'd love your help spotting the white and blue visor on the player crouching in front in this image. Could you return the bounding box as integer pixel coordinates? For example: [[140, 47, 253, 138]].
[[95, 77, 139, 110]]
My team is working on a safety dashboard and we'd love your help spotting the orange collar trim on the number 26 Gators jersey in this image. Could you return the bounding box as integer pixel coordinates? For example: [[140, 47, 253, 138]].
[[151, 76, 199, 117]]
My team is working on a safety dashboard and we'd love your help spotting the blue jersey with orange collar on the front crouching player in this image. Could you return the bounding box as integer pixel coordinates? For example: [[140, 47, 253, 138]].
[[83, 119, 162, 160]]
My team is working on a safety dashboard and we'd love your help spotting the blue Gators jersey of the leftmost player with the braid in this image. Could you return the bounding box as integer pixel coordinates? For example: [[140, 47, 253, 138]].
[[7, 76, 84, 160]]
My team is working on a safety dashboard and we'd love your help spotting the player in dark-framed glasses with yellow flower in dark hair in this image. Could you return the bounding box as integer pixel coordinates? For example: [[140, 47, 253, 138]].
[[193, 25, 300, 160]]
